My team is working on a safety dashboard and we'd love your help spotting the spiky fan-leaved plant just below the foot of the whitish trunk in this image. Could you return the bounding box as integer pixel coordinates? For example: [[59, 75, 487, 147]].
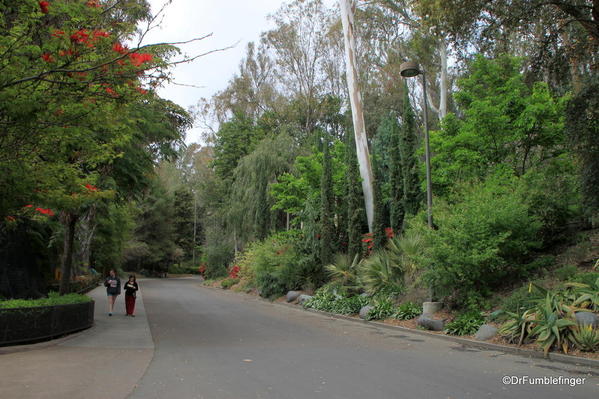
[[359, 251, 404, 295]]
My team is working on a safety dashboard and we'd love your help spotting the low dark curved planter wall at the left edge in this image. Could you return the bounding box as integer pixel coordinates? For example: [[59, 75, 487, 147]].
[[0, 301, 95, 346]]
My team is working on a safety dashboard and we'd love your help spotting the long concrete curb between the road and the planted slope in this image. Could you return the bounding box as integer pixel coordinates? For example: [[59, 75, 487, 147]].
[[202, 285, 599, 369]]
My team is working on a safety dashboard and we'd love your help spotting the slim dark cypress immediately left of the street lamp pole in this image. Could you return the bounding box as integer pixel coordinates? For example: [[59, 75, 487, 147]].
[[399, 86, 422, 215]]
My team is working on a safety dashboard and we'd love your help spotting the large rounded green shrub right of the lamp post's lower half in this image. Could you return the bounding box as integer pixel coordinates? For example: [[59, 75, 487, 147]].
[[425, 173, 540, 306]]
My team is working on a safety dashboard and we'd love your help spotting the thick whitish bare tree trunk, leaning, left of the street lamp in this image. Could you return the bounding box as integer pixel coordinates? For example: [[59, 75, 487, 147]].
[[339, 0, 374, 232]]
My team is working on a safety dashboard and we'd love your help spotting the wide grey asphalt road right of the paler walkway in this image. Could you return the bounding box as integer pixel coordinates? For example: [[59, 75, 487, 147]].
[[130, 279, 599, 399]]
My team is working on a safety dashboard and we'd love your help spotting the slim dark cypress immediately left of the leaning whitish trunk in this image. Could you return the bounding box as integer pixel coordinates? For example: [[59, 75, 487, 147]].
[[345, 132, 364, 259]]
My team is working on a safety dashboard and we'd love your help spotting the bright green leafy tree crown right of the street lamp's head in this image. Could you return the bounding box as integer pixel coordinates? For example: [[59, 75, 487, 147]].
[[431, 56, 565, 194]]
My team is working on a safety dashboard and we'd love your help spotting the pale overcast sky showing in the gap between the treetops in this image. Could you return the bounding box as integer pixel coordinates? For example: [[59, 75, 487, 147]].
[[146, 0, 284, 143]]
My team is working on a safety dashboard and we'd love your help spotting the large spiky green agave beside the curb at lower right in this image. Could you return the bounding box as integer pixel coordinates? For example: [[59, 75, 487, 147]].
[[530, 294, 576, 356]]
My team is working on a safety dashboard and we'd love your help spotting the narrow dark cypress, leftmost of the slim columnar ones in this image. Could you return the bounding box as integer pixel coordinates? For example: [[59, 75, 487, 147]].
[[320, 136, 335, 265]]
